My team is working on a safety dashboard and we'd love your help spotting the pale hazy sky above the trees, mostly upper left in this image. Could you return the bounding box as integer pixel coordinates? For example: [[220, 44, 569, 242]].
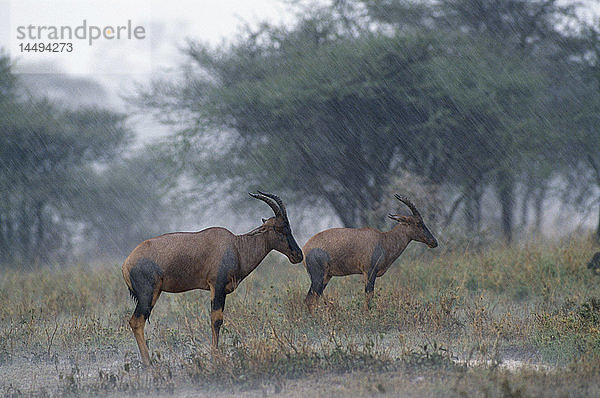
[[0, 0, 600, 141]]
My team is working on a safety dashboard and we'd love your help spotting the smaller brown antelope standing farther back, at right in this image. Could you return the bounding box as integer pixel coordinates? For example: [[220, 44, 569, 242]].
[[302, 195, 437, 311]]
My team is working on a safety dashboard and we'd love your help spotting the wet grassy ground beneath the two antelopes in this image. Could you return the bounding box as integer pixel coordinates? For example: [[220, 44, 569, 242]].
[[0, 240, 600, 397]]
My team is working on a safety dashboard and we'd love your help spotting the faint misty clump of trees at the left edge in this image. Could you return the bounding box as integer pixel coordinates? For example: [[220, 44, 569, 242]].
[[0, 52, 173, 266]]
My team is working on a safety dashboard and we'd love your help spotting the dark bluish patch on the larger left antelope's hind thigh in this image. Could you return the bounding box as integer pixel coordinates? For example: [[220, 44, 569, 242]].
[[129, 258, 163, 320]]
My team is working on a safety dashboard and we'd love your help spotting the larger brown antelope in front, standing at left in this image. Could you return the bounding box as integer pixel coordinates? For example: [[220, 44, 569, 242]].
[[123, 191, 302, 365]]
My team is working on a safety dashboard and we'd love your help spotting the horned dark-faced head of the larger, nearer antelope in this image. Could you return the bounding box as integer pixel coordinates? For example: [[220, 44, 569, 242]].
[[250, 191, 303, 264]]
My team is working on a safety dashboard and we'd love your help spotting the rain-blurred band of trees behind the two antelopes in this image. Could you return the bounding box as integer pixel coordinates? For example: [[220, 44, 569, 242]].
[[0, 0, 600, 267]]
